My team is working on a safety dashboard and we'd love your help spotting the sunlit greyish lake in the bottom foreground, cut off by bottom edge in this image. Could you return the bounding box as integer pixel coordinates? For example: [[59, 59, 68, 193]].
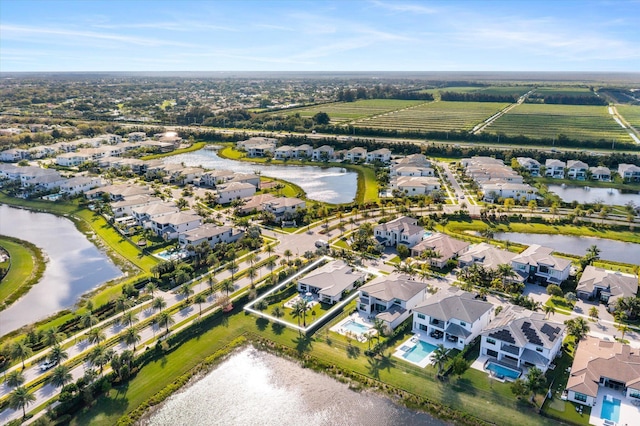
[[141, 348, 444, 426]]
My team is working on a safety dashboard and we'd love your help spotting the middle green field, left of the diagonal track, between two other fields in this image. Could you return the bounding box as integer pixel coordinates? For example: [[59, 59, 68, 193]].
[[356, 101, 509, 132]]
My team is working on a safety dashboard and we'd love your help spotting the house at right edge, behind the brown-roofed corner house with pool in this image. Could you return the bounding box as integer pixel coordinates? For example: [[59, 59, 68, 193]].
[[576, 265, 638, 309]]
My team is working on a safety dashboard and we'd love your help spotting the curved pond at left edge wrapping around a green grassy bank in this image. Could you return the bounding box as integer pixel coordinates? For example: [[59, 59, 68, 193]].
[[0, 204, 122, 336]]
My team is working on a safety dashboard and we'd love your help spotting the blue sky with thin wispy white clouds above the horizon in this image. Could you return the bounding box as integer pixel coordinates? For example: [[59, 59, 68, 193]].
[[0, 0, 640, 72]]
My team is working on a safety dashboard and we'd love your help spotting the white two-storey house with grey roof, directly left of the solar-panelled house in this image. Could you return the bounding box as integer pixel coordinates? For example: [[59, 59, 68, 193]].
[[413, 289, 494, 350]]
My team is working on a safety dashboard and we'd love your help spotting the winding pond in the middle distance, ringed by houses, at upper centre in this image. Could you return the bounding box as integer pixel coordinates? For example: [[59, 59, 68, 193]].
[[164, 149, 358, 204]]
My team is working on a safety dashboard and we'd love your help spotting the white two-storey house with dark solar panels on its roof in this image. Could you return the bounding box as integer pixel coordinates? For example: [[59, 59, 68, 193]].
[[480, 305, 566, 372]]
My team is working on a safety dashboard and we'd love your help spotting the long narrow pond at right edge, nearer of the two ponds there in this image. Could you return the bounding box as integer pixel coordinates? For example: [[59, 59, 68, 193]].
[[494, 232, 640, 265]]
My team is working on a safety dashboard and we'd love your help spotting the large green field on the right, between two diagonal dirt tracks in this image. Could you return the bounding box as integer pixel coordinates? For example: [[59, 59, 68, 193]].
[[484, 103, 631, 142]]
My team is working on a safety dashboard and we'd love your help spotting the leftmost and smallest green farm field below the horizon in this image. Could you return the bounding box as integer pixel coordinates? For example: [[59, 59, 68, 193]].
[[278, 99, 425, 124]]
